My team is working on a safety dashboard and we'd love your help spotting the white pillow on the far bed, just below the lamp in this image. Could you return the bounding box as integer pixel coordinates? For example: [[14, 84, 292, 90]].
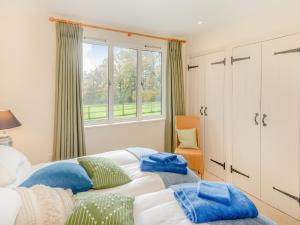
[[0, 145, 31, 187]]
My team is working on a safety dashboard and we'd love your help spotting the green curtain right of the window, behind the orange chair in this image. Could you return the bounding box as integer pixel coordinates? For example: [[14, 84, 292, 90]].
[[165, 41, 185, 152]]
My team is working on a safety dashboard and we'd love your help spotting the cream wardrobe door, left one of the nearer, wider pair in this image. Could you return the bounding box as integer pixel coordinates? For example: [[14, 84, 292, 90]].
[[231, 43, 261, 198]]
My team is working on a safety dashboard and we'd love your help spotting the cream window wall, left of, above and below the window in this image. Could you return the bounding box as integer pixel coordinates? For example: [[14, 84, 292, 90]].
[[0, 0, 166, 163]]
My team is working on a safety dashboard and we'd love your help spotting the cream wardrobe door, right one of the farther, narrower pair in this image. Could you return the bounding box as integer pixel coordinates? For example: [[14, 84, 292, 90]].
[[204, 52, 225, 179]]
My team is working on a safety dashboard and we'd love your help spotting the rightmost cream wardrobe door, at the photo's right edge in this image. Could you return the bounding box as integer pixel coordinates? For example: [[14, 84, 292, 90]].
[[261, 35, 300, 218]]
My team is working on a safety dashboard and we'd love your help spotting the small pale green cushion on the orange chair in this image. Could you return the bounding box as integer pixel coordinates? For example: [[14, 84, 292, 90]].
[[177, 128, 198, 149]]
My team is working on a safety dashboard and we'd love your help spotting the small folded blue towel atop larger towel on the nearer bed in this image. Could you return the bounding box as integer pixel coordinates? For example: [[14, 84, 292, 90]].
[[197, 180, 231, 205]]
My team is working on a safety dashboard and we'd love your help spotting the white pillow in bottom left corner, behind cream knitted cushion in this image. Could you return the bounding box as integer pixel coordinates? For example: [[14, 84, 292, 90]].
[[0, 188, 22, 225]]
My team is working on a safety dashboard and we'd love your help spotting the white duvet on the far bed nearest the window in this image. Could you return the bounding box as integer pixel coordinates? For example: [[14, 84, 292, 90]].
[[7, 150, 165, 196]]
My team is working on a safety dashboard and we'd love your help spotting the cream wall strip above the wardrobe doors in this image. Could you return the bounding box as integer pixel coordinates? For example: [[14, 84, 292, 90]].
[[187, 1, 300, 56]]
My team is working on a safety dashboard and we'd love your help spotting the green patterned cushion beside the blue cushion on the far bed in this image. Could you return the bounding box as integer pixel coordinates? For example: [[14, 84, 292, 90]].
[[78, 157, 131, 189]]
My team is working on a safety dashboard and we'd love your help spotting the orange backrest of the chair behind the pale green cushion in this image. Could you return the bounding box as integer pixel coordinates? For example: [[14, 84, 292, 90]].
[[175, 116, 200, 148]]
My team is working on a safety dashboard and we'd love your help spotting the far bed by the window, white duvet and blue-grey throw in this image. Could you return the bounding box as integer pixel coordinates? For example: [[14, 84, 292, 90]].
[[5, 147, 199, 196]]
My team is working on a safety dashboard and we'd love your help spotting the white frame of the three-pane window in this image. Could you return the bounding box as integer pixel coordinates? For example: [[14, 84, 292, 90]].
[[83, 38, 166, 127]]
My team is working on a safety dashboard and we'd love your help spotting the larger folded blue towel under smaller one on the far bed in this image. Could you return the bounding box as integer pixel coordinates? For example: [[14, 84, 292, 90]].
[[140, 156, 187, 174]]
